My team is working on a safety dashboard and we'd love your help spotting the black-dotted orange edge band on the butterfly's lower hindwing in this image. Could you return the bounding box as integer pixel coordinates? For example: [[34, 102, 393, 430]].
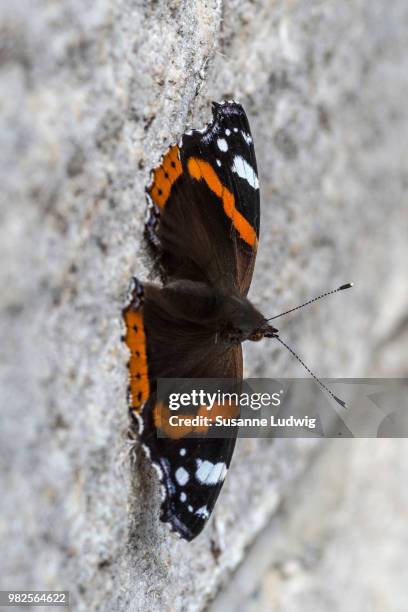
[[124, 306, 149, 412]]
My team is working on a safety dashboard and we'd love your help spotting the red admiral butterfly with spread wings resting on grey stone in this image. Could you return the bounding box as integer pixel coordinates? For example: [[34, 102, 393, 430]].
[[123, 102, 350, 540]]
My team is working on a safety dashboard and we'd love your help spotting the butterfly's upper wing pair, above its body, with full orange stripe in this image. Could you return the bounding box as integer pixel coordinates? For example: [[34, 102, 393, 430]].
[[146, 102, 260, 294]]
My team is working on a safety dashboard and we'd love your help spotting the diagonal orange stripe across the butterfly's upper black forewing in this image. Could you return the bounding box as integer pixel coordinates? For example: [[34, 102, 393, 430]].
[[187, 157, 257, 248]]
